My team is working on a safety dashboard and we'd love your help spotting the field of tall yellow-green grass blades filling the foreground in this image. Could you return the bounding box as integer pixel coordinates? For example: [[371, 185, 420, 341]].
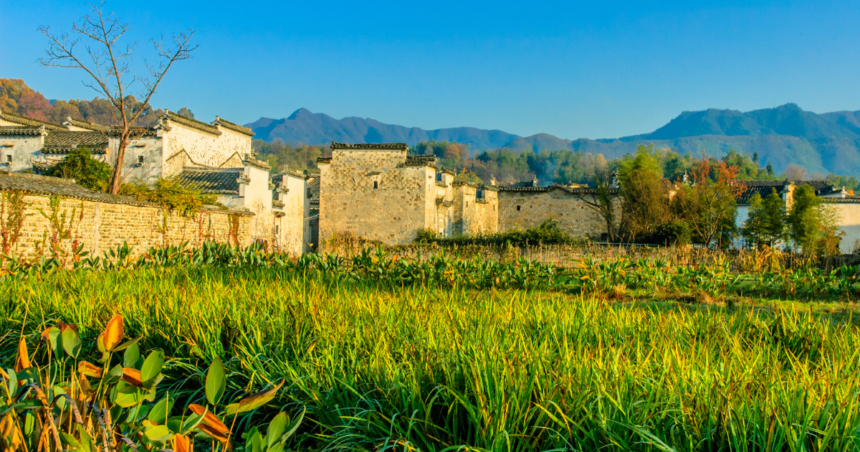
[[0, 267, 860, 451]]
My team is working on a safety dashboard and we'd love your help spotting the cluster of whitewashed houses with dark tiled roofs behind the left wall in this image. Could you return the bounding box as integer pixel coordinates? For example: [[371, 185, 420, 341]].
[[0, 111, 308, 254]]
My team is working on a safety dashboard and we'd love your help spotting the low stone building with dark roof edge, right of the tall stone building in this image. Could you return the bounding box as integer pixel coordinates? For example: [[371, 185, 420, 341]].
[[498, 180, 621, 240]]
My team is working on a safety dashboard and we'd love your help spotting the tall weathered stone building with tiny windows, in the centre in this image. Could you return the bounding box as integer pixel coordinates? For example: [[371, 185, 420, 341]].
[[317, 143, 498, 245]]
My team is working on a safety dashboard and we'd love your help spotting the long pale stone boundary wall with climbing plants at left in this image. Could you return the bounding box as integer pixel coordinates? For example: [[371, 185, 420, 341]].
[[0, 190, 253, 263]]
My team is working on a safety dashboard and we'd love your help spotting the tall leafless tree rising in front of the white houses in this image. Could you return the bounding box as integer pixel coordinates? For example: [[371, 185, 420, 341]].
[[39, 2, 197, 194]]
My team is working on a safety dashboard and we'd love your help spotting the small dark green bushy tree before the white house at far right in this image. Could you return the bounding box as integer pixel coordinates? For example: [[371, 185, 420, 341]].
[[741, 189, 787, 248]]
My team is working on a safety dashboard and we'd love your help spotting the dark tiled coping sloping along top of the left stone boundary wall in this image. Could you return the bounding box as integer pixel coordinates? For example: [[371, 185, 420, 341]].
[[0, 172, 155, 206]]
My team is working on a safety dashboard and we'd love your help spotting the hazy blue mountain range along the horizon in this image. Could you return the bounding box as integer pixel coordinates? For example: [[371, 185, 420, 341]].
[[247, 104, 860, 176]]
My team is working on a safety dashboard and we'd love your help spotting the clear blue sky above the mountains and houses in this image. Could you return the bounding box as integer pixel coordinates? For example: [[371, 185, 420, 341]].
[[0, 0, 860, 139]]
